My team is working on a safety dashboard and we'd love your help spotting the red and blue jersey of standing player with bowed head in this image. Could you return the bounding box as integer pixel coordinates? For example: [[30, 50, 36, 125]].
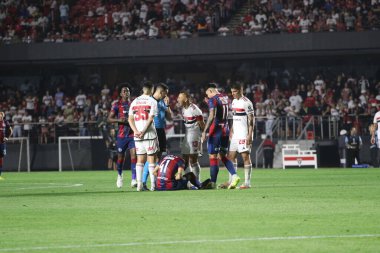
[[208, 93, 229, 137]]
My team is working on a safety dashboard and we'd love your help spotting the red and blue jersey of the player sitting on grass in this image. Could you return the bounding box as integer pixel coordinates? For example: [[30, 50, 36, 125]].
[[156, 155, 185, 190]]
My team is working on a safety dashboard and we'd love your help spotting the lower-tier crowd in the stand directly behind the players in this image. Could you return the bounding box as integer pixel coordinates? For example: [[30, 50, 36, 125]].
[[0, 70, 380, 143]]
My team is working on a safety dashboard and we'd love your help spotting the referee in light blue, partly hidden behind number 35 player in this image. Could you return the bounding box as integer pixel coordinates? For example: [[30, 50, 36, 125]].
[[143, 83, 172, 190]]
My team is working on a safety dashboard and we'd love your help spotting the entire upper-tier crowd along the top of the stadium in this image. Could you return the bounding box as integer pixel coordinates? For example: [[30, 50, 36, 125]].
[[0, 0, 380, 44]]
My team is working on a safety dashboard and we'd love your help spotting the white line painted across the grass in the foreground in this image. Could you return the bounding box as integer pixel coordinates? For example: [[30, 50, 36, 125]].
[[0, 234, 380, 252]]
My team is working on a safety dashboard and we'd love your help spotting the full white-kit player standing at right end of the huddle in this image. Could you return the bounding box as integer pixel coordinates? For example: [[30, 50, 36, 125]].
[[228, 84, 255, 189]]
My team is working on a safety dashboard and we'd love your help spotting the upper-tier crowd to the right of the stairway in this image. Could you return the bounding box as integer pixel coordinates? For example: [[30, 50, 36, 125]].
[[235, 0, 380, 36]]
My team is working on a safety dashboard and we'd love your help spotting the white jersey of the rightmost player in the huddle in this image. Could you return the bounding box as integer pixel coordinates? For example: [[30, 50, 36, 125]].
[[232, 96, 255, 139]]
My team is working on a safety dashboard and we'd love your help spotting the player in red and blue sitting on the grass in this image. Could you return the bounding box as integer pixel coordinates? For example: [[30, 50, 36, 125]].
[[153, 155, 210, 191]]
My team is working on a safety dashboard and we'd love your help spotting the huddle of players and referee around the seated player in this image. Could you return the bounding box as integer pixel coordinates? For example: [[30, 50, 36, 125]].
[[108, 82, 254, 191]]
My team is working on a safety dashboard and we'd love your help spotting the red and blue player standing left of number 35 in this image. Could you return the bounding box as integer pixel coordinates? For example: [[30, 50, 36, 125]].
[[108, 86, 137, 188]]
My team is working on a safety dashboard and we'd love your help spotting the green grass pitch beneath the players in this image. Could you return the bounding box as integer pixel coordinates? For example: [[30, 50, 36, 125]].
[[0, 169, 380, 253]]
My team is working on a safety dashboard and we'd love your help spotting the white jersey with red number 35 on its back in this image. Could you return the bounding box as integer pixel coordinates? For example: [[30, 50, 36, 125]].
[[129, 95, 158, 140]]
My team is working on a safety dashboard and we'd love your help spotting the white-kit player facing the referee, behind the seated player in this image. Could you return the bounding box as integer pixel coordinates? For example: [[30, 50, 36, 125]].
[[177, 91, 205, 180]]
